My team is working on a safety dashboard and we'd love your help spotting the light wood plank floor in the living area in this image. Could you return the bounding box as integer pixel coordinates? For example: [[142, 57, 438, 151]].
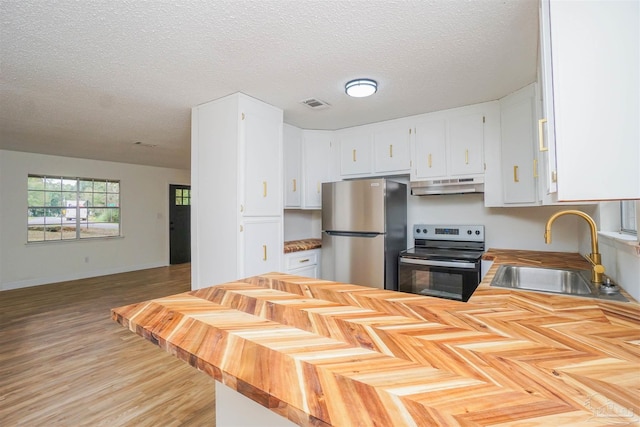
[[0, 264, 215, 426]]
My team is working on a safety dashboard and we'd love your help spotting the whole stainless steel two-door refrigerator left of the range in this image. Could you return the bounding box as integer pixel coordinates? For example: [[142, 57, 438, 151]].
[[321, 178, 407, 290]]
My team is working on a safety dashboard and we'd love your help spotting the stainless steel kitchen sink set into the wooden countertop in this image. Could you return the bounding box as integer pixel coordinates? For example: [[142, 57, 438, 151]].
[[491, 265, 628, 301]]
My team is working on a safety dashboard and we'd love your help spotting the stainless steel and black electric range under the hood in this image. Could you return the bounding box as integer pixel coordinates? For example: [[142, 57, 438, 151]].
[[398, 224, 485, 301]]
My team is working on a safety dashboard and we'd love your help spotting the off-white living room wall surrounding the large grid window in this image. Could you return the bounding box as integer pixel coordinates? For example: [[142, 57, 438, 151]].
[[0, 150, 190, 290]]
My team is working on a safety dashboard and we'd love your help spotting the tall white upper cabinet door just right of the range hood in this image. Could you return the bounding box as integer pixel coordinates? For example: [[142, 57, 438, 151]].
[[500, 85, 538, 204]]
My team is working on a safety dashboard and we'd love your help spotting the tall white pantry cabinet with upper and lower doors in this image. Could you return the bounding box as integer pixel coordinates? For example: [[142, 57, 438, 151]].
[[191, 93, 284, 289]]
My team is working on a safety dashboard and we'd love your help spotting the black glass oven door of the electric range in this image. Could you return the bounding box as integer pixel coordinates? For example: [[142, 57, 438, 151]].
[[398, 256, 480, 301]]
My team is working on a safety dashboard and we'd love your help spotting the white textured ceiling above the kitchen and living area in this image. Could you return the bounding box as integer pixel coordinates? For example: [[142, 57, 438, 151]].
[[0, 0, 538, 168]]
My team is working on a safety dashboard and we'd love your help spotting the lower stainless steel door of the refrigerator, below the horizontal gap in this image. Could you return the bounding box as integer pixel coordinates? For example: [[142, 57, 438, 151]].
[[320, 232, 384, 289]]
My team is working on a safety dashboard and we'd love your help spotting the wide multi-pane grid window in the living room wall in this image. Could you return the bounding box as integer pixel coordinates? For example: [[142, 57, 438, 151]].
[[27, 175, 120, 242]]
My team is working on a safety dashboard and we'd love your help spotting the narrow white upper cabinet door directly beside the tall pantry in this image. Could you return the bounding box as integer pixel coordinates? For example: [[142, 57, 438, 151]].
[[282, 124, 302, 208]]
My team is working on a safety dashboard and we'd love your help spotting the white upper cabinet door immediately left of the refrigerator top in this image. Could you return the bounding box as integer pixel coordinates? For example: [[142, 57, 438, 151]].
[[302, 131, 333, 209]]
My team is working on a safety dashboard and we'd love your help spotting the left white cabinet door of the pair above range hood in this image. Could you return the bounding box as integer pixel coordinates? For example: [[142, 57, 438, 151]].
[[412, 119, 447, 179]]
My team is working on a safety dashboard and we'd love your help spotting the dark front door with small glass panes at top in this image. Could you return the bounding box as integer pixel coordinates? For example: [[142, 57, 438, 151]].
[[169, 184, 191, 264]]
